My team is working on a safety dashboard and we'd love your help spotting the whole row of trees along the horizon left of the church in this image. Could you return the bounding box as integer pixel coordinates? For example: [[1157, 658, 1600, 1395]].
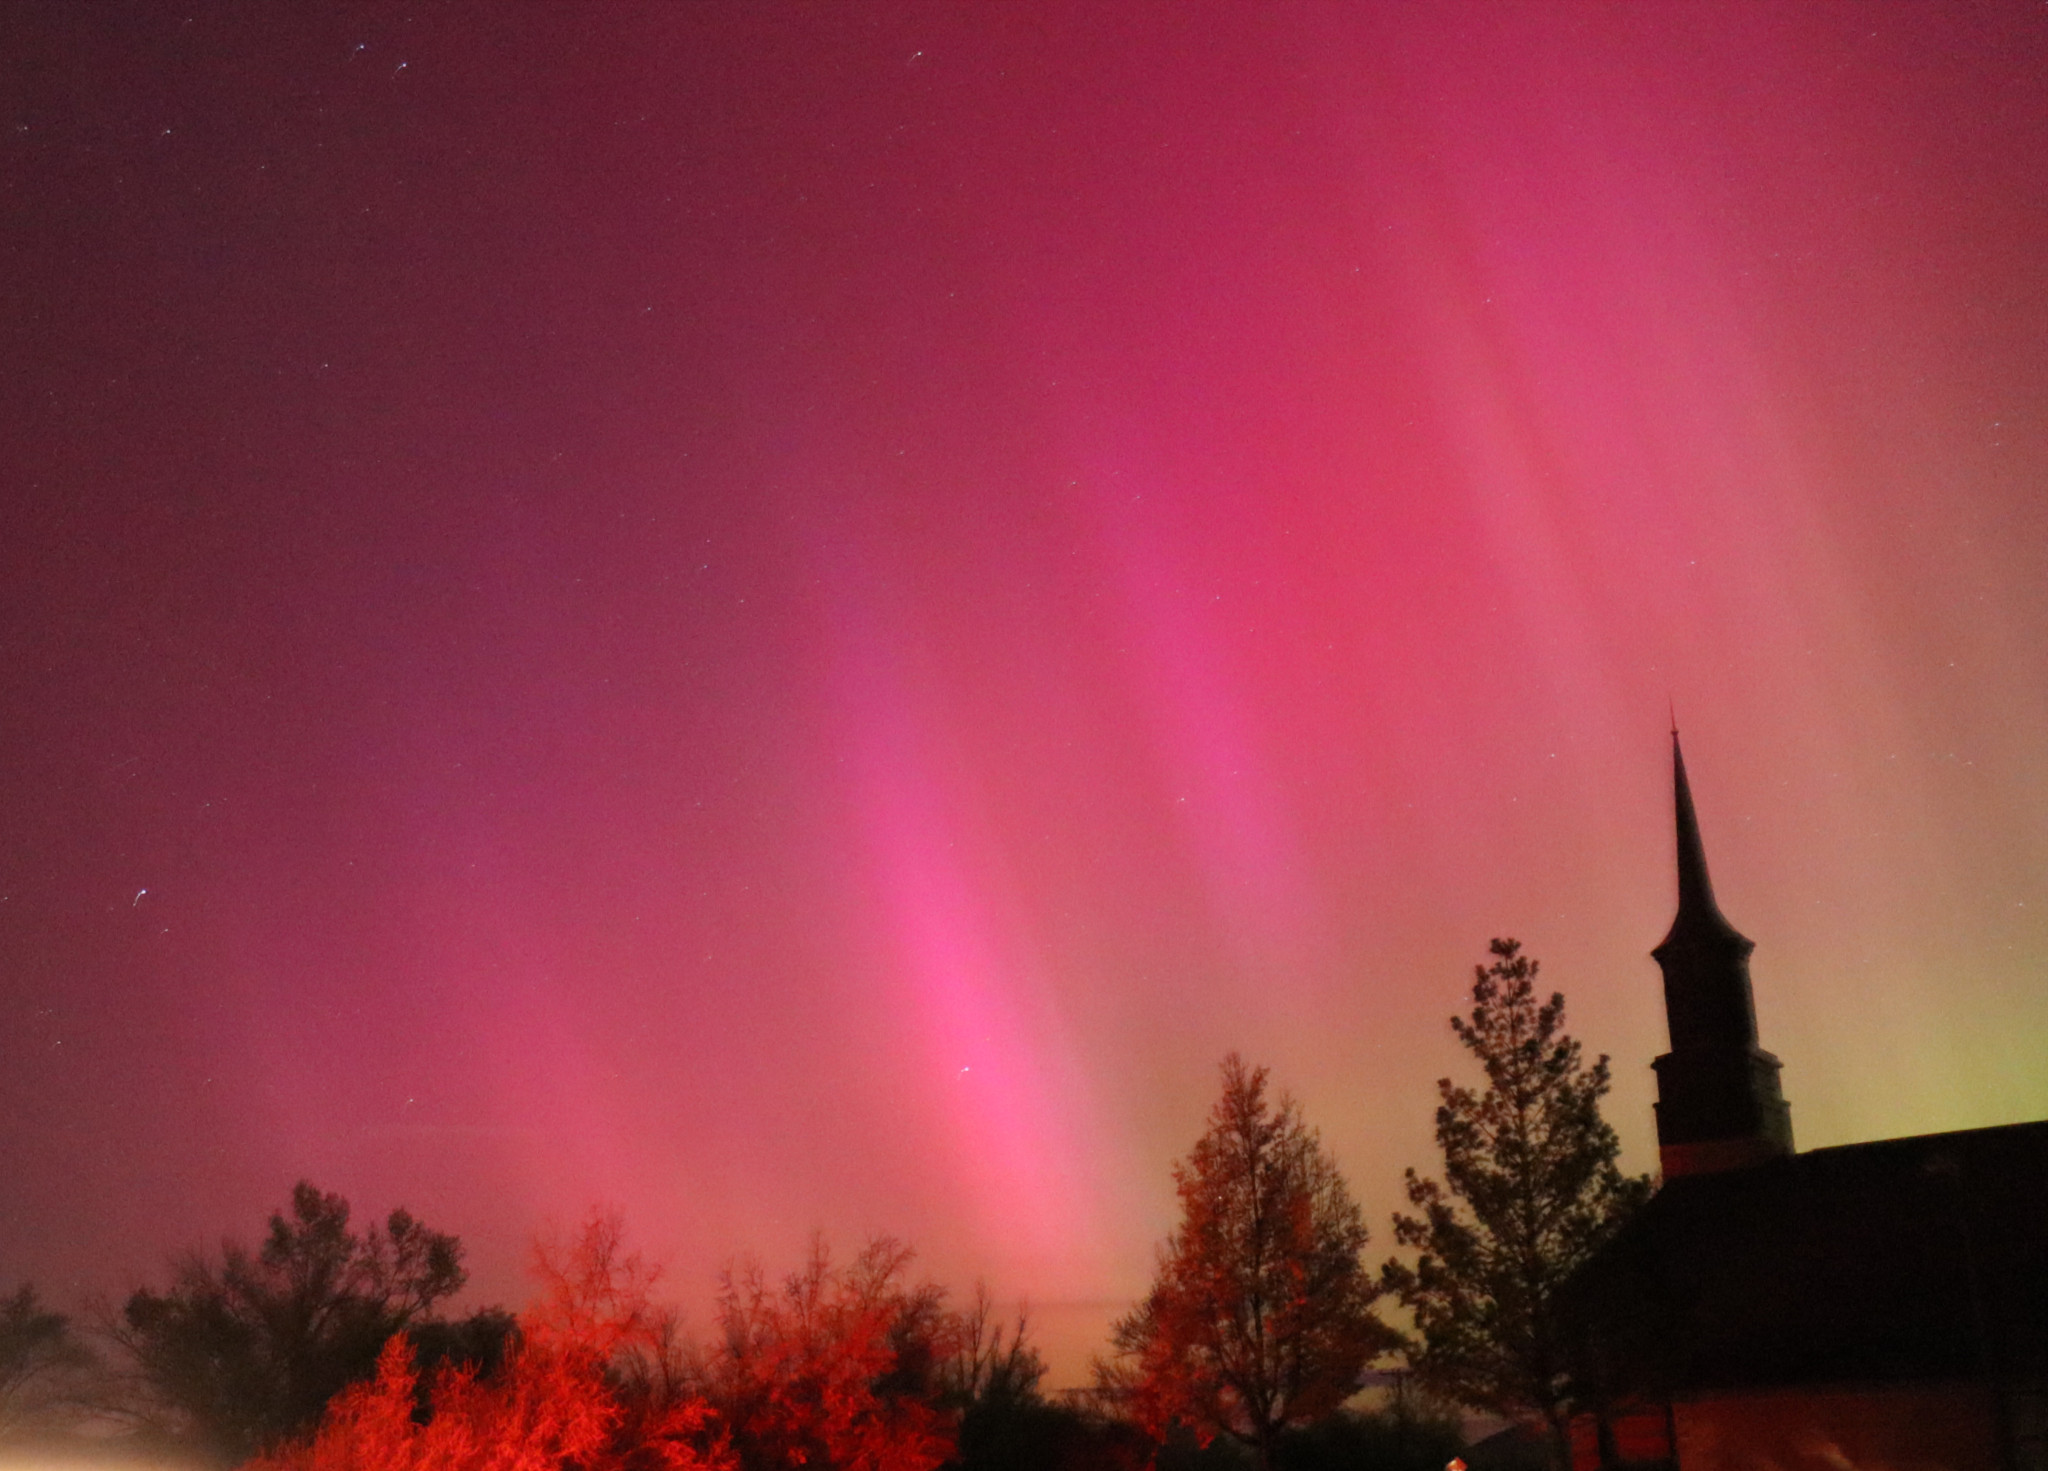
[[0, 940, 1649, 1471]]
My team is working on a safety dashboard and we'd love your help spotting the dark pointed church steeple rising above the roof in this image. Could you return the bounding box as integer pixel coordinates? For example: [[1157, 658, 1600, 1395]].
[[1651, 729, 1792, 1178]]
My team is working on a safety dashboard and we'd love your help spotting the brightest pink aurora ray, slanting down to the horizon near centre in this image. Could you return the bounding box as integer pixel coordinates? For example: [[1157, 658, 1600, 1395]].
[[813, 524, 1104, 1295]]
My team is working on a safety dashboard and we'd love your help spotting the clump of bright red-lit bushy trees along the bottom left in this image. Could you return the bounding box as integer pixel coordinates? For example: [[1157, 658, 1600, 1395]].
[[256, 1217, 991, 1471]]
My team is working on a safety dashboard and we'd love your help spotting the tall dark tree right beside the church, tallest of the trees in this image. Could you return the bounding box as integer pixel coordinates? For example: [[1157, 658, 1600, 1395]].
[[1380, 940, 1651, 1465]]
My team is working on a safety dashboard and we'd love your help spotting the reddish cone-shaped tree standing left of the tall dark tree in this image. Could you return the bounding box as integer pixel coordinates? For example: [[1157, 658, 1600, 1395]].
[[1098, 1053, 1395, 1467]]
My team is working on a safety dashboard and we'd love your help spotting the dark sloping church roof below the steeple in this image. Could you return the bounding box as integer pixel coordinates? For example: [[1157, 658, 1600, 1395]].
[[1565, 1123, 2048, 1397]]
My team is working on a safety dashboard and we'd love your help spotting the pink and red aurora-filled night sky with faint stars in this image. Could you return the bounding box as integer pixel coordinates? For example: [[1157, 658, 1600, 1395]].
[[0, 0, 2048, 1383]]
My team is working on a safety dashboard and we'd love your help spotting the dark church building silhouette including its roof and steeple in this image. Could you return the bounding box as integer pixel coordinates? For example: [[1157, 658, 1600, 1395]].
[[1561, 731, 2048, 1471]]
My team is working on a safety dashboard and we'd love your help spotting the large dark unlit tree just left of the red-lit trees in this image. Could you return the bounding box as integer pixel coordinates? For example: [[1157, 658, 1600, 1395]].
[[115, 1180, 479, 1463]]
